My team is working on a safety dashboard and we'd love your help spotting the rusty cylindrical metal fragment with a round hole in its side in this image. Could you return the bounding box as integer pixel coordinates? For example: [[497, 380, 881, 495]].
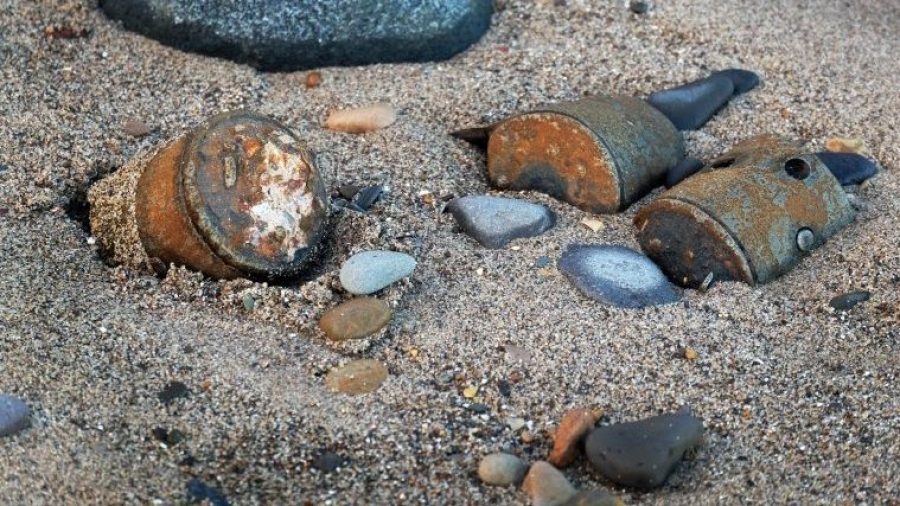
[[634, 135, 854, 288]]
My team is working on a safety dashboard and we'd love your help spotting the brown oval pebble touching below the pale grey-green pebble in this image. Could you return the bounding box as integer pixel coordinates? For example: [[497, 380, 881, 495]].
[[319, 297, 391, 341]]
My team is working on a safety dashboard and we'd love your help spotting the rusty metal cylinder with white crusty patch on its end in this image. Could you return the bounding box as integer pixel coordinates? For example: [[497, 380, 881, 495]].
[[135, 111, 327, 279]]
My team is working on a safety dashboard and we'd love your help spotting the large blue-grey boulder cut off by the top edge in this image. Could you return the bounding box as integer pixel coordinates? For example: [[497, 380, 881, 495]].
[[100, 0, 493, 70]]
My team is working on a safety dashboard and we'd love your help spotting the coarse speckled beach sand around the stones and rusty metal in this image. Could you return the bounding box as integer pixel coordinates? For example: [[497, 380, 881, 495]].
[[0, 0, 900, 505]]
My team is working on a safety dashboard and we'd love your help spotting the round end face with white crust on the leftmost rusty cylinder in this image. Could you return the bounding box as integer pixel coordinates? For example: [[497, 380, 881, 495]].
[[182, 111, 327, 277]]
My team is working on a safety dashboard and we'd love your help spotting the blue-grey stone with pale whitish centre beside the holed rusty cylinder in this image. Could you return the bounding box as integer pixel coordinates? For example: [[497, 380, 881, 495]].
[[559, 244, 681, 308]]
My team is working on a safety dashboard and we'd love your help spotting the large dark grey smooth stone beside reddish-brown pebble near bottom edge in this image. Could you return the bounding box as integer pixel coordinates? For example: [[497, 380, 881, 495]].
[[585, 413, 703, 488]]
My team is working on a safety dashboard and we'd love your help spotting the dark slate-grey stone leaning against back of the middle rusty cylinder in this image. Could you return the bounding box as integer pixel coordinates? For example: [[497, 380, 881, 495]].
[[647, 74, 734, 130]]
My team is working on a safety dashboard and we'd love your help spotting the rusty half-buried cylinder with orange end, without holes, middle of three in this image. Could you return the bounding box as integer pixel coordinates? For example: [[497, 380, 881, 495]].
[[488, 95, 684, 213]]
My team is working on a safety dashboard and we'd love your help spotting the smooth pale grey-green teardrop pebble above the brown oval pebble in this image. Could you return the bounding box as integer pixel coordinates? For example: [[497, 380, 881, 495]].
[[340, 251, 416, 295]]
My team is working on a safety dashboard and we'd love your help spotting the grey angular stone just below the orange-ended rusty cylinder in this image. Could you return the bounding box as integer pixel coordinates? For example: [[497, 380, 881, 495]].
[[447, 195, 556, 249]]
